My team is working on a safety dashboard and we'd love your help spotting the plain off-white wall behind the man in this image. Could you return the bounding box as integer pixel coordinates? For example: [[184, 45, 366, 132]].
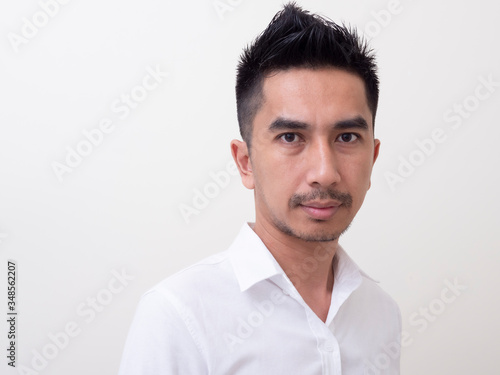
[[0, 0, 500, 375]]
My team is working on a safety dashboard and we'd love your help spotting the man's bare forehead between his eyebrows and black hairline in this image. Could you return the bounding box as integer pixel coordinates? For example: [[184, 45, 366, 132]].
[[254, 67, 373, 131]]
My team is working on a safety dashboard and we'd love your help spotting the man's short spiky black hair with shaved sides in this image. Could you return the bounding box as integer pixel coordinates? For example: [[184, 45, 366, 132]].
[[236, 2, 379, 150]]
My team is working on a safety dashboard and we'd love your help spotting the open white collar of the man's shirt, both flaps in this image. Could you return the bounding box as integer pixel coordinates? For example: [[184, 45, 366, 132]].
[[228, 223, 378, 292]]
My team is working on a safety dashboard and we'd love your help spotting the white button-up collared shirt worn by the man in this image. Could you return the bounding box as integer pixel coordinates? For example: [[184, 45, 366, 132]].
[[119, 223, 401, 375]]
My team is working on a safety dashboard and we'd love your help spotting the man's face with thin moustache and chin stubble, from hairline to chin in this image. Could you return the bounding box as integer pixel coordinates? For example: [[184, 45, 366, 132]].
[[234, 68, 380, 241]]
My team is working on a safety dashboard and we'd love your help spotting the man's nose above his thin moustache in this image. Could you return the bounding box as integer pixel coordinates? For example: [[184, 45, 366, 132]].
[[306, 140, 340, 188]]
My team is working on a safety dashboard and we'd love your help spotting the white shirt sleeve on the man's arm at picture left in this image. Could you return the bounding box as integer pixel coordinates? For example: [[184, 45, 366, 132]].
[[119, 290, 208, 375]]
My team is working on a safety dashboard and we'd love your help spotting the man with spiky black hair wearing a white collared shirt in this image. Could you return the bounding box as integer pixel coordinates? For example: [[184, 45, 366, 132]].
[[120, 4, 401, 375]]
